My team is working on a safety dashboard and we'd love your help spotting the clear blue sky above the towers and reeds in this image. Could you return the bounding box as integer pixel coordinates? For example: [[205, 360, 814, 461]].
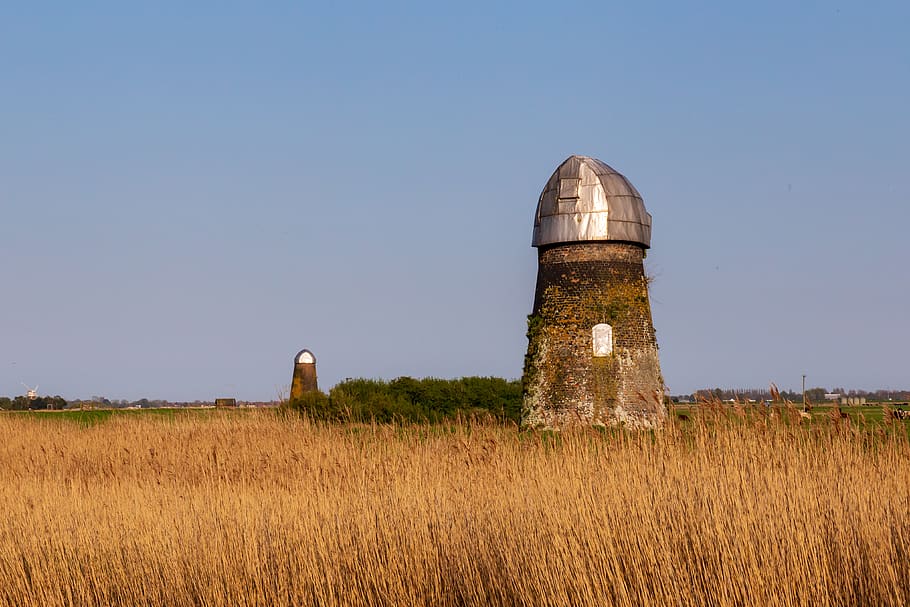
[[0, 1, 910, 400]]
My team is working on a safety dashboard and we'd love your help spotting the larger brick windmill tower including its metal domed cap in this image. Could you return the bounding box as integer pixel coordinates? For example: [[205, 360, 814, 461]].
[[522, 156, 665, 428]]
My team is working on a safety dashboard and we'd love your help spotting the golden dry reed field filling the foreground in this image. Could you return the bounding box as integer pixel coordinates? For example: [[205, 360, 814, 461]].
[[0, 407, 910, 607]]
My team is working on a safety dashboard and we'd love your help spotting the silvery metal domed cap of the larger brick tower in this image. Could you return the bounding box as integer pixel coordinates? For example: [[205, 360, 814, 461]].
[[531, 156, 651, 248]]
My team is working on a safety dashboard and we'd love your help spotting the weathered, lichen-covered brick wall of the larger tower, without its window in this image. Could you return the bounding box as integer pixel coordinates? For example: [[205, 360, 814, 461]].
[[522, 241, 665, 427]]
